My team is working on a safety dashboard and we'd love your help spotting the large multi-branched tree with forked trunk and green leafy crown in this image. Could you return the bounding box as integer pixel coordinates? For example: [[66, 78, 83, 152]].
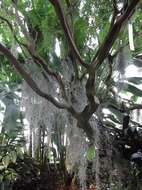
[[0, 0, 142, 190]]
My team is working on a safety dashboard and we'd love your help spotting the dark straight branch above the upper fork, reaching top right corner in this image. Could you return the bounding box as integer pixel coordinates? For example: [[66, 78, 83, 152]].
[[92, 0, 140, 66]]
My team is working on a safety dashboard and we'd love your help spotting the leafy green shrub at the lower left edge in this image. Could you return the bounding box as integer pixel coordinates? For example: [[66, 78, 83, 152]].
[[0, 132, 25, 182]]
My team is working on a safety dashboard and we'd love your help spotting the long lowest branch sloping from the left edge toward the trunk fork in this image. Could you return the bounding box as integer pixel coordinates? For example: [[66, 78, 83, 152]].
[[0, 43, 70, 109]]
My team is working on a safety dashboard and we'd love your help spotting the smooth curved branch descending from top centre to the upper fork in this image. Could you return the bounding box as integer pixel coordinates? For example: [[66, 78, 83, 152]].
[[49, 0, 88, 68]]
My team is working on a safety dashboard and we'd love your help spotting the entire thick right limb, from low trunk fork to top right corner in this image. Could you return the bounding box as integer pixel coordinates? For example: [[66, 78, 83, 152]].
[[82, 0, 139, 120]]
